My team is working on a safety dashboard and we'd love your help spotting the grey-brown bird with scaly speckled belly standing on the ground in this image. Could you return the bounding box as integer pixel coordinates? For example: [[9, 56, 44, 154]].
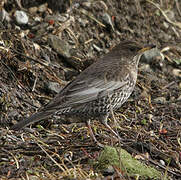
[[11, 40, 156, 145]]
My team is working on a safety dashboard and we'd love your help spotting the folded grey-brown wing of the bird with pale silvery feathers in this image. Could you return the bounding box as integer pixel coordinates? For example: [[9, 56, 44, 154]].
[[44, 70, 129, 111]]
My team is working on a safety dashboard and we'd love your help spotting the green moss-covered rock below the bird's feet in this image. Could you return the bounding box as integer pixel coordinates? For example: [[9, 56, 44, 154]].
[[97, 146, 161, 179]]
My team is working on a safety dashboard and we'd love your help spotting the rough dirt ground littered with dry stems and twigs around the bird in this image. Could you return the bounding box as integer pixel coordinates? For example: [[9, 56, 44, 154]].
[[0, 0, 181, 179]]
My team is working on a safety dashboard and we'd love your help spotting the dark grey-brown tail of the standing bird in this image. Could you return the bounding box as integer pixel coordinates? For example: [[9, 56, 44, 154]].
[[11, 111, 52, 131]]
